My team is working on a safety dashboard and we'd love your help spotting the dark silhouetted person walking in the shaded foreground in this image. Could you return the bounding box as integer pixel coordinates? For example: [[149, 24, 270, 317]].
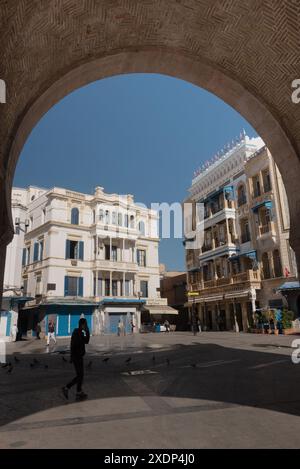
[[62, 318, 90, 400]]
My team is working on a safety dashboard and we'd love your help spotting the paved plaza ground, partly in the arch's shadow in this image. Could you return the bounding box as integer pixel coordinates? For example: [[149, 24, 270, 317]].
[[0, 332, 300, 449]]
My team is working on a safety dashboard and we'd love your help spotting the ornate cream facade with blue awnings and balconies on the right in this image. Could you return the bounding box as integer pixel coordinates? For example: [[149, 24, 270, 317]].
[[186, 135, 297, 331]]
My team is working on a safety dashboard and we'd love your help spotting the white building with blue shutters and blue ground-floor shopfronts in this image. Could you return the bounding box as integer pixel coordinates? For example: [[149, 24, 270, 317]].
[[1, 183, 173, 336]]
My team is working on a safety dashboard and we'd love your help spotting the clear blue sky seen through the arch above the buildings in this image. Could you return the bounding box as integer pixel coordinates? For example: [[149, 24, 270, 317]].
[[14, 74, 256, 270]]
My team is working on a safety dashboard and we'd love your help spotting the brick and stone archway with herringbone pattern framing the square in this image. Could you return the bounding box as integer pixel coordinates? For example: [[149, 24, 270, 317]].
[[0, 0, 300, 300]]
